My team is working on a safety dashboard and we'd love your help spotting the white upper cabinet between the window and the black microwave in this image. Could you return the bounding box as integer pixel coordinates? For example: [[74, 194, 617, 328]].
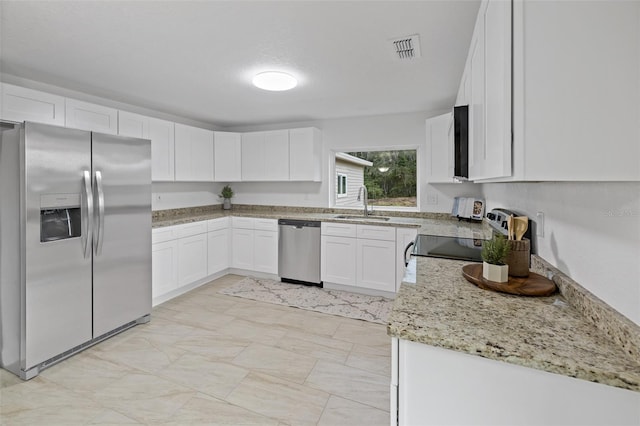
[[425, 113, 454, 183]]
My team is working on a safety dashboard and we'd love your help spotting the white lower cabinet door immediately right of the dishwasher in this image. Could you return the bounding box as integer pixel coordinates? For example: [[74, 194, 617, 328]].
[[320, 235, 357, 286]]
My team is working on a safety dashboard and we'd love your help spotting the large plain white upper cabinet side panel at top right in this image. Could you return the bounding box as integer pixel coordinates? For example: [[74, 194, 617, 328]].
[[513, 1, 640, 181]]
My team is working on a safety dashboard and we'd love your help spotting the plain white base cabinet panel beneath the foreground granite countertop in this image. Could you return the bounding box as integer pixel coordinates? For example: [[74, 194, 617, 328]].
[[390, 338, 640, 426]]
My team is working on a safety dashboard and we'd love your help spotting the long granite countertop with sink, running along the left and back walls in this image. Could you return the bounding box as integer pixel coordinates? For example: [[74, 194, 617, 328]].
[[152, 206, 491, 239]]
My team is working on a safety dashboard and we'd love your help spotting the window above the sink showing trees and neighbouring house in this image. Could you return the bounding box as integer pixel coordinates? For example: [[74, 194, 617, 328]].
[[335, 149, 418, 209]]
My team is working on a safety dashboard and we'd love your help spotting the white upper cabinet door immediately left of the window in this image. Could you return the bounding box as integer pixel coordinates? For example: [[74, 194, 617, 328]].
[[289, 127, 322, 182]]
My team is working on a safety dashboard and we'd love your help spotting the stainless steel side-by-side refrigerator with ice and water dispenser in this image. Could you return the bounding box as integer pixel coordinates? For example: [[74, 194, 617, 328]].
[[0, 122, 151, 379]]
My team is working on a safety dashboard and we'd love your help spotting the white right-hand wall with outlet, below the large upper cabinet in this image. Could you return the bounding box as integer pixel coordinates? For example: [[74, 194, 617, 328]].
[[480, 182, 640, 324]]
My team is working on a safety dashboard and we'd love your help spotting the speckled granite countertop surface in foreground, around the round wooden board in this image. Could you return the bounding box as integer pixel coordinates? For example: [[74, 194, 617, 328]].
[[388, 257, 640, 391]]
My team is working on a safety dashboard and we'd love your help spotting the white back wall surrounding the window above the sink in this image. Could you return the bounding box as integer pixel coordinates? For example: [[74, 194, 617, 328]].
[[224, 111, 480, 212]]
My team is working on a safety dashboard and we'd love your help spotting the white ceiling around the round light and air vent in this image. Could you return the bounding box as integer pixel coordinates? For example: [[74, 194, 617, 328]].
[[0, 0, 479, 127]]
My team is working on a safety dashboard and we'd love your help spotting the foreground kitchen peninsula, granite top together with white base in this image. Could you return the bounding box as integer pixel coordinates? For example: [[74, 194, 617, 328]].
[[388, 256, 640, 425]]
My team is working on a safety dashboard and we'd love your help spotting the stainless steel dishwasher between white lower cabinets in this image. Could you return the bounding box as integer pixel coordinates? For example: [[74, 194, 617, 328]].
[[278, 219, 322, 287]]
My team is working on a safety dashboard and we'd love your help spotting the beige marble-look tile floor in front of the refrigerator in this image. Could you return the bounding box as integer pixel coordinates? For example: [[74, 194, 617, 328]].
[[0, 275, 391, 426]]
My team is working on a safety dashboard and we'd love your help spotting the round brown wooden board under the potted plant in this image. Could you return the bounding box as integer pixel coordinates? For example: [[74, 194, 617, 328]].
[[462, 263, 558, 297]]
